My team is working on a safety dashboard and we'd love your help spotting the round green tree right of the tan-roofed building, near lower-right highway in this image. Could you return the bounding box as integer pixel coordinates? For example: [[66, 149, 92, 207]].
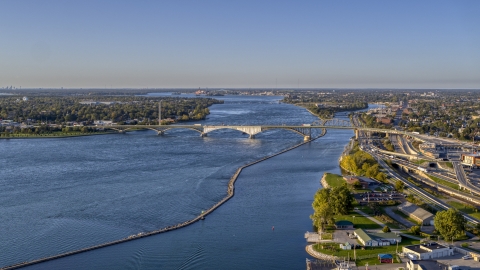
[[433, 208, 467, 243]]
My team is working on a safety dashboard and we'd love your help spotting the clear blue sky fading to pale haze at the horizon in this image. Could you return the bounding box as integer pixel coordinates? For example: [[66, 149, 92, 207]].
[[0, 0, 480, 88]]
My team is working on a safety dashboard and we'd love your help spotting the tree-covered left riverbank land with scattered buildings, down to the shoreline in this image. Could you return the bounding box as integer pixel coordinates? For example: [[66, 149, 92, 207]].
[[0, 94, 223, 137]]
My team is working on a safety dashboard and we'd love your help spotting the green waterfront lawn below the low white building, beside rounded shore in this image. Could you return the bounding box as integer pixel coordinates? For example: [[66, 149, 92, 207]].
[[313, 237, 420, 266]]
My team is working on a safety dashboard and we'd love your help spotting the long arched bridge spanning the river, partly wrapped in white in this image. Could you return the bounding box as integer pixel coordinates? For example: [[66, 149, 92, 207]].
[[89, 119, 424, 141]]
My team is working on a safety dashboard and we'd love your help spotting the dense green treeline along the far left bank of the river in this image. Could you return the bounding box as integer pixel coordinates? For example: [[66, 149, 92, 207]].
[[0, 96, 223, 124]]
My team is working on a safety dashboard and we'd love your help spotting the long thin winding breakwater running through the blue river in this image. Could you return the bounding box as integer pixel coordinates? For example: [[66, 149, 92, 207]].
[[0, 129, 327, 270]]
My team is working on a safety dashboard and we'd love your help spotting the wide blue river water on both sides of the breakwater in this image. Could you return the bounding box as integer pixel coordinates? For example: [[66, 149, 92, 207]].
[[0, 94, 372, 269]]
